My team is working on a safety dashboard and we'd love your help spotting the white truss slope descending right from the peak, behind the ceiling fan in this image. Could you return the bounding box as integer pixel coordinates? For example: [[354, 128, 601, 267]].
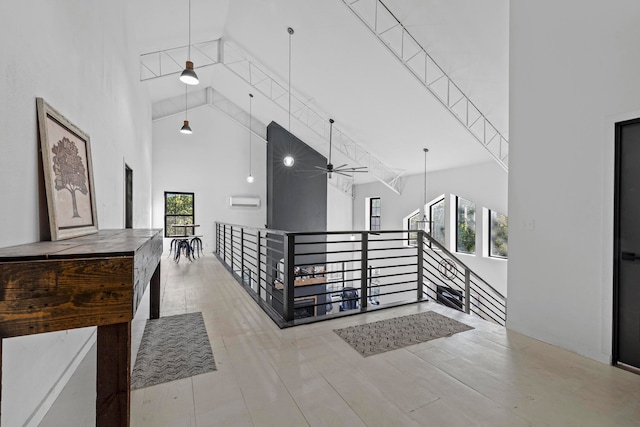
[[221, 40, 404, 194]]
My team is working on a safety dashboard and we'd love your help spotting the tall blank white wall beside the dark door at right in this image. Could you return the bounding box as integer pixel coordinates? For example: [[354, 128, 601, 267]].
[[507, 0, 640, 362]]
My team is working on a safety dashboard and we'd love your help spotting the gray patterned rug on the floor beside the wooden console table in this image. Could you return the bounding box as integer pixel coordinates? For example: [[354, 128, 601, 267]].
[[131, 313, 216, 390]]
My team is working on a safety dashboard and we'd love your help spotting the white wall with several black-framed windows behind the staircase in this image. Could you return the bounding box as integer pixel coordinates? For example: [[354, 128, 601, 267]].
[[353, 162, 509, 296]]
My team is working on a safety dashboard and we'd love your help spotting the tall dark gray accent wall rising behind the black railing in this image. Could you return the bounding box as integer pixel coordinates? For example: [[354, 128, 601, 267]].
[[267, 122, 327, 231]]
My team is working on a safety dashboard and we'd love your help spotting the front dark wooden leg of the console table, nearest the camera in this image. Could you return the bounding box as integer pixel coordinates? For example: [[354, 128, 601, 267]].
[[96, 322, 131, 427]]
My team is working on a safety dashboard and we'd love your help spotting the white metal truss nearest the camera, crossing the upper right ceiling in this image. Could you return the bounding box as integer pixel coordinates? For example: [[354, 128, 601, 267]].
[[342, 0, 509, 171]]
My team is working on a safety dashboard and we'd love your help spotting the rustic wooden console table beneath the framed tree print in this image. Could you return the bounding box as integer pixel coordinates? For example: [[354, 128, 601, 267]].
[[0, 229, 162, 427]]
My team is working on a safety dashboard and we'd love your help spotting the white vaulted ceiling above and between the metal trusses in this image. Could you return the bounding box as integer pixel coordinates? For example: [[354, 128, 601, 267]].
[[132, 0, 509, 181]]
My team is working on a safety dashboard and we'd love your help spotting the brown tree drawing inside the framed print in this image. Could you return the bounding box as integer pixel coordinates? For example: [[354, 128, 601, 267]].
[[51, 137, 89, 218]]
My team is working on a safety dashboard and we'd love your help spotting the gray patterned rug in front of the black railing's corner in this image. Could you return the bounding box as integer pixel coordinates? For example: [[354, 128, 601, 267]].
[[334, 311, 473, 357]]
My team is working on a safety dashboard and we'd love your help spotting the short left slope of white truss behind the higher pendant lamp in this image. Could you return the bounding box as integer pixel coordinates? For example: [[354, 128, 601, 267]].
[[140, 39, 220, 81]]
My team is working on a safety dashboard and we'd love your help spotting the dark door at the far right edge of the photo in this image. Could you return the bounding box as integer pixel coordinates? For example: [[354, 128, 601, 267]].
[[613, 119, 640, 369]]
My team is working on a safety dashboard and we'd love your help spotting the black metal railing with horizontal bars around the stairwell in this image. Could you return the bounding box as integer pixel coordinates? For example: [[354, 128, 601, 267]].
[[215, 222, 506, 327]]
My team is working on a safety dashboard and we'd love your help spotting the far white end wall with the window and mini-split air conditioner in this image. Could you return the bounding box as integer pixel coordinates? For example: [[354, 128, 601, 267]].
[[153, 106, 267, 252]]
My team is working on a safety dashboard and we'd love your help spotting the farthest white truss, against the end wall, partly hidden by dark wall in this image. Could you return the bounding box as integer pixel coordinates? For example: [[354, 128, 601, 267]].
[[152, 86, 353, 198]]
